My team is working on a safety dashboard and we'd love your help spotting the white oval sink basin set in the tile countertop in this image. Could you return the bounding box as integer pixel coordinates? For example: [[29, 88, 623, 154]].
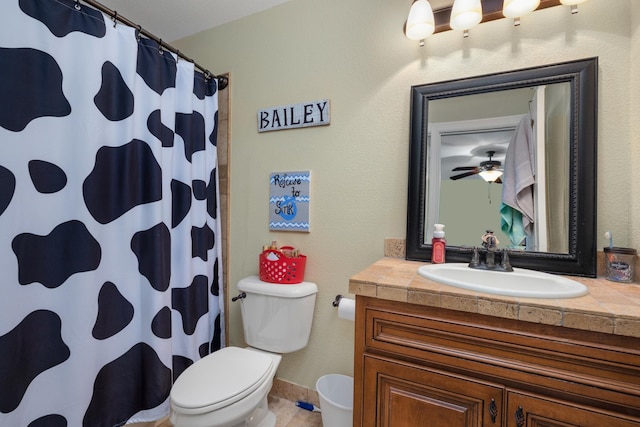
[[418, 263, 589, 298]]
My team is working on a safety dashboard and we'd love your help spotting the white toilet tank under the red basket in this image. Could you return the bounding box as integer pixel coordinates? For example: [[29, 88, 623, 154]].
[[238, 276, 318, 353]]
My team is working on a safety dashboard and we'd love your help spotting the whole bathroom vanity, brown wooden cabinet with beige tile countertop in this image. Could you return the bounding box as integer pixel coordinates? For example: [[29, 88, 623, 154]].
[[349, 258, 640, 427]]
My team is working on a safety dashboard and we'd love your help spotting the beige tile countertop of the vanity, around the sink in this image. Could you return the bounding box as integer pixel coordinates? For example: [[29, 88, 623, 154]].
[[349, 257, 640, 338]]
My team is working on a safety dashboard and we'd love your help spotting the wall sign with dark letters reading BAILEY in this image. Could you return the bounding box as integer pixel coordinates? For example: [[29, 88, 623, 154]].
[[258, 99, 331, 132]]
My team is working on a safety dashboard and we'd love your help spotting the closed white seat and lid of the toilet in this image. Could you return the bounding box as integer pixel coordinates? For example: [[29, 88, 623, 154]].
[[171, 347, 273, 414]]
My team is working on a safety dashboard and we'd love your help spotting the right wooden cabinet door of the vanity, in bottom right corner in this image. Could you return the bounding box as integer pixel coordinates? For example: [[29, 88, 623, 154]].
[[506, 390, 640, 427]]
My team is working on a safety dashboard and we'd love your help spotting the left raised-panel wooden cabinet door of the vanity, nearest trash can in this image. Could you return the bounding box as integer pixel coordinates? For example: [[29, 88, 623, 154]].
[[363, 356, 504, 427]]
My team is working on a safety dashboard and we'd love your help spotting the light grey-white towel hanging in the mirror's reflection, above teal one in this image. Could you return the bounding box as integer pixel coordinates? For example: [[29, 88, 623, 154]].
[[501, 114, 536, 234]]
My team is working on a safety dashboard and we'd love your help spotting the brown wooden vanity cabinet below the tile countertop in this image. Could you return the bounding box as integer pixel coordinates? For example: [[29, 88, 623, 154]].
[[354, 296, 640, 427]]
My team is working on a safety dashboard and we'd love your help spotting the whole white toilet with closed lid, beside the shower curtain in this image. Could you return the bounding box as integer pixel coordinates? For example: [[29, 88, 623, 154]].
[[170, 276, 318, 427]]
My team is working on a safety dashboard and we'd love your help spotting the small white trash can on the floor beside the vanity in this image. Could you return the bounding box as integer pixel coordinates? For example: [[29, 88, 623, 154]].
[[316, 374, 353, 427]]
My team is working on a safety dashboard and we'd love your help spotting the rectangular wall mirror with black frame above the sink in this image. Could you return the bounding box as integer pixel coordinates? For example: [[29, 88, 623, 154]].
[[406, 58, 598, 277]]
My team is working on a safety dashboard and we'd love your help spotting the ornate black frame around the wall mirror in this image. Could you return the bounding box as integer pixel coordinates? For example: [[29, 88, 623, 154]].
[[406, 58, 598, 277]]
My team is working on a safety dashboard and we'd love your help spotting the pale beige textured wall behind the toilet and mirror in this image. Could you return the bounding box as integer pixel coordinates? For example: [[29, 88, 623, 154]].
[[176, 0, 640, 388]]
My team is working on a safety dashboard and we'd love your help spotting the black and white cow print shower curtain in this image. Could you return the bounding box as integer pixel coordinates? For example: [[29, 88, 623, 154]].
[[0, 0, 224, 427]]
